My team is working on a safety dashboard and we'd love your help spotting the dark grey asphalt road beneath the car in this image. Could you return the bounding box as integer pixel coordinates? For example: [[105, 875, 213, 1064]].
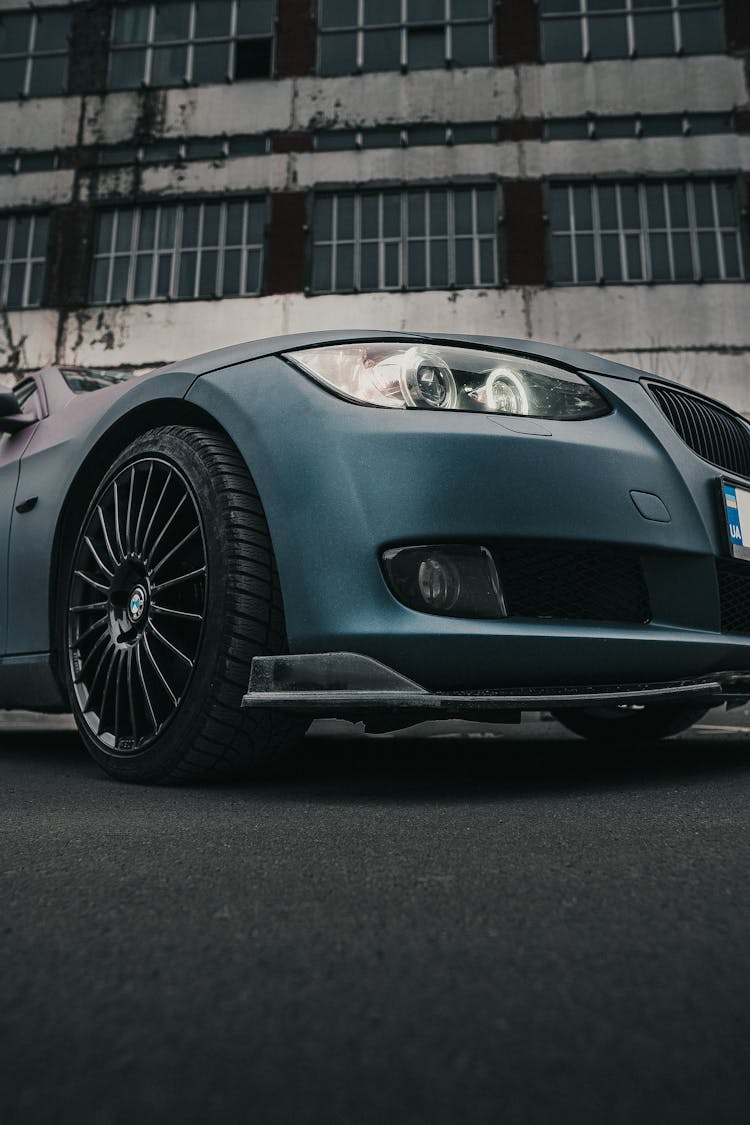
[[0, 711, 750, 1125]]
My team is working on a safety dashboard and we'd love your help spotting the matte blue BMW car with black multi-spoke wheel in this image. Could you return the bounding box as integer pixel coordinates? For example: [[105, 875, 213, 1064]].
[[5, 332, 750, 783]]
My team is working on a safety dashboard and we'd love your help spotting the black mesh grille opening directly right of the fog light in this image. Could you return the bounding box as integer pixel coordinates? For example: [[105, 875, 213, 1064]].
[[493, 541, 651, 623]]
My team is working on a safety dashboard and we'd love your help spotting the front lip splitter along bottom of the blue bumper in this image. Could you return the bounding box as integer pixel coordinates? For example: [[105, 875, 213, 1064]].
[[242, 653, 750, 718]]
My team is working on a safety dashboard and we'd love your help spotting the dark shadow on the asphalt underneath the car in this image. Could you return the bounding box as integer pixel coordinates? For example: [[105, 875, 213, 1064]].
[[0, 722, 750, 803]]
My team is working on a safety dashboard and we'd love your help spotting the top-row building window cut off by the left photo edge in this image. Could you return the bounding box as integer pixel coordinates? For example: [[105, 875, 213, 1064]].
[[0, 9, 71, 98]]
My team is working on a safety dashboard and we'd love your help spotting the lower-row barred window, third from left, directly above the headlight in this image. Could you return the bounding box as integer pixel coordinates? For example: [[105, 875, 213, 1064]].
[[313, 187, 498, 293]]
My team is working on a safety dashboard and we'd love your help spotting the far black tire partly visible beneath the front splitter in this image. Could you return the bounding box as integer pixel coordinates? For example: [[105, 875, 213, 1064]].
[[552, 703, 708, 744]]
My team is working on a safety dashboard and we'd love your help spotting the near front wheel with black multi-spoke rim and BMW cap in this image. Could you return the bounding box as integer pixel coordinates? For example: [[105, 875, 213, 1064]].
[[63, 425, 305, 784]]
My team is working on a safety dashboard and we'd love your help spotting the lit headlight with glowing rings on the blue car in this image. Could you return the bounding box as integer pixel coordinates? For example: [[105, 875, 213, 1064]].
[[284, 343, 609, 420]]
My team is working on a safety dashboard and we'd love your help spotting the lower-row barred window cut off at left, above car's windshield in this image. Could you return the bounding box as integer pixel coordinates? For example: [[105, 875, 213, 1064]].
[[0, 214, 49, 308]]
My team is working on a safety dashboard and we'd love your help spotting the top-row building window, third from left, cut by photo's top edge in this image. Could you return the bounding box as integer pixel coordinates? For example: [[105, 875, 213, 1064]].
[[318, 0, 495, 74]]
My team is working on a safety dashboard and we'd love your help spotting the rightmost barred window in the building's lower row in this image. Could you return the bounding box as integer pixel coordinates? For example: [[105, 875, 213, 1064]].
[[550, 180, 744, 285]]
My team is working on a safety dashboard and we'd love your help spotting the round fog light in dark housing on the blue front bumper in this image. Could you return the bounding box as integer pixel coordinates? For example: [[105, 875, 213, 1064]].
[[382, 543, 507, 618]]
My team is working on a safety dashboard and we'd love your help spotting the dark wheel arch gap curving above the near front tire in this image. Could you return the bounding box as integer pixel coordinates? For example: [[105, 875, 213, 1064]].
[[48, 398, 236, 692]]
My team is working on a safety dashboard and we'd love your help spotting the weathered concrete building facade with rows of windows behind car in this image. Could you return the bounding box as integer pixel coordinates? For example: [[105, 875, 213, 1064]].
[[0, 0, 750, 415]]
